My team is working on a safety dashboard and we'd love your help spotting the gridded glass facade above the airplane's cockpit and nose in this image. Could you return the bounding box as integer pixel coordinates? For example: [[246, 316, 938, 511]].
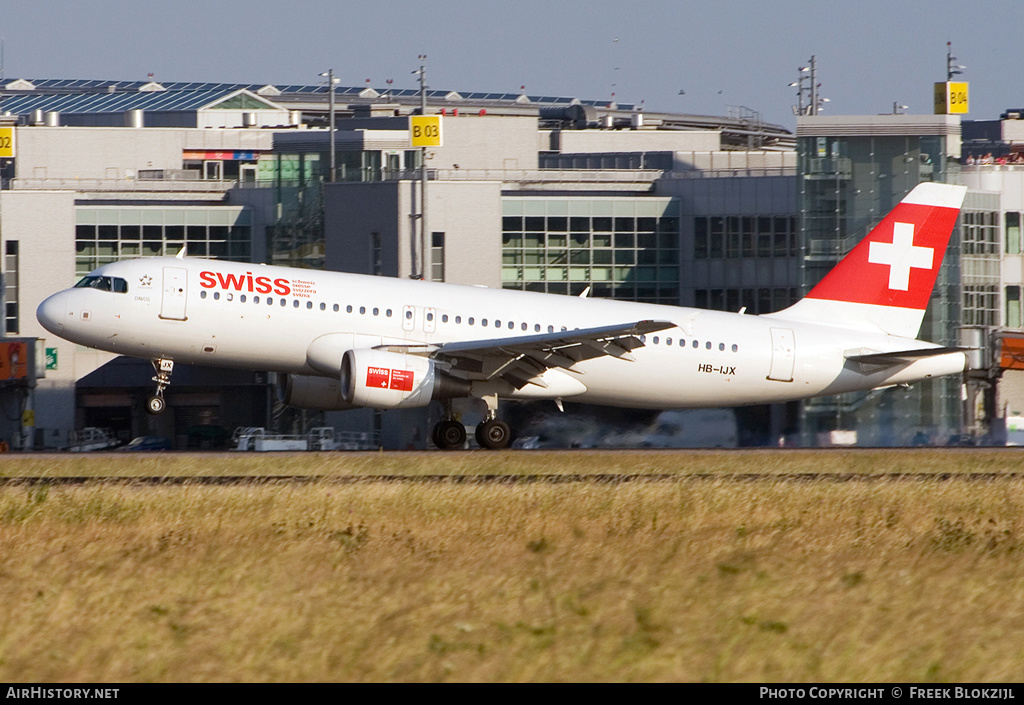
[[75, 206, 252, 277]]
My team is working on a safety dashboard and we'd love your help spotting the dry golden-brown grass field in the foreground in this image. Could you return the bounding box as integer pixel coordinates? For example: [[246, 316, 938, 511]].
[[0, 450, 1024, 682]]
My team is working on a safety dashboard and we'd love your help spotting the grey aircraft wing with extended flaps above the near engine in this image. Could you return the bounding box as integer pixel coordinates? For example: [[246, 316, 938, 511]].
[[382, 321, 676, 389]]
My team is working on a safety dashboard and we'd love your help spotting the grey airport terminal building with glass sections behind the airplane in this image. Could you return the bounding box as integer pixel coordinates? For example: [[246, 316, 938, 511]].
[[0, 75, 1024, 448]]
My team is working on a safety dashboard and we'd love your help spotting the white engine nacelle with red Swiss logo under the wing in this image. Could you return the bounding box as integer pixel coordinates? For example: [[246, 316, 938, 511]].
[[340, 348, 470, 409]]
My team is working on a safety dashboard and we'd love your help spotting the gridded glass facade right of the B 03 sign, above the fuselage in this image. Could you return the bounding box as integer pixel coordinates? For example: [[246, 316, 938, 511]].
[[502, 197, 680, 304]]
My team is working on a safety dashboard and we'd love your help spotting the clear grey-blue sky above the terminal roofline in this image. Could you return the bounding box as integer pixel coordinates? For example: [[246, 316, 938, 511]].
[[0, 0, 1024, 129]]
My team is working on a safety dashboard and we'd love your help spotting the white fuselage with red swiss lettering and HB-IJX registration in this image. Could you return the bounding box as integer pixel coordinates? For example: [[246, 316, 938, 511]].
[[39, 257, 965, 408]]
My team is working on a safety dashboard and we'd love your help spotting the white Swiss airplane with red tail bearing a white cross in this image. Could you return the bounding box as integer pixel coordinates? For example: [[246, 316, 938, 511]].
[[36, 182, 967, 449]]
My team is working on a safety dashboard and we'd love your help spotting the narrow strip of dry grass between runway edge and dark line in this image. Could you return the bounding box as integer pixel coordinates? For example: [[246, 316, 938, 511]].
[[0, 448, 1024, 478]]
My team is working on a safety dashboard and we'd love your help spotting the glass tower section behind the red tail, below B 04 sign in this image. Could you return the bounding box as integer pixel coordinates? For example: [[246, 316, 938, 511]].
[[797, 127, 962, 446]]
